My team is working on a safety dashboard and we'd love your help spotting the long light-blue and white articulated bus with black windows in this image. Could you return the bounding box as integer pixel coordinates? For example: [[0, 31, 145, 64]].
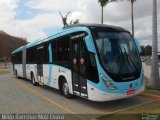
[[12, 24, 144, 101]]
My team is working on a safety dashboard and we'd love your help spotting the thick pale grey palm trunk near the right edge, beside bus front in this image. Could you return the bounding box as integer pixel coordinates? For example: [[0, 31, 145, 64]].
[[150, 0, 160, 88]]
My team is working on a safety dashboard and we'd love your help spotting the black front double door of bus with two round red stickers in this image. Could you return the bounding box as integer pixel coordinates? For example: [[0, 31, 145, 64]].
[[71, 38, 88, 97]]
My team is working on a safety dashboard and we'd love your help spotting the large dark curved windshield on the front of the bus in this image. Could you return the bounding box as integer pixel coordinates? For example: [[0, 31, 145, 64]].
[[94, 30, 142, 82]]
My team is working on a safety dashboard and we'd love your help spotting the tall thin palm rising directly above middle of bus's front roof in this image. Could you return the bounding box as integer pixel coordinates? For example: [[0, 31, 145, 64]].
[[98, 0, 117, 24]]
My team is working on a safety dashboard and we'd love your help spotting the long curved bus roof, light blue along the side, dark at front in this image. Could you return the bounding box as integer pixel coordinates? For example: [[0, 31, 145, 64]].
[[12, 24, 127, 54]]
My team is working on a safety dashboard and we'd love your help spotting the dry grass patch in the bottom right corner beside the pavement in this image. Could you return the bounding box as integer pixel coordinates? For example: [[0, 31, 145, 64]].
[[97, 100, 160, 120]]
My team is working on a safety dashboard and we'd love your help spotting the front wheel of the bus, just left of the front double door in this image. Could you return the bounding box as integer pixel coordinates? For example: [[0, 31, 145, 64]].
[[62, 81, 72, 99]]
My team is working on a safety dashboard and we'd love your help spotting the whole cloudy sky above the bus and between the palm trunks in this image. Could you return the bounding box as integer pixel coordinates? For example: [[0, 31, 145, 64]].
[[0, 0, 160, 50]]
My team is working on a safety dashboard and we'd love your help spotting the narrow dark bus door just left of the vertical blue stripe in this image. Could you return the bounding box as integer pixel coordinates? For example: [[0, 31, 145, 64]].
[[37, 46, 44, 84]]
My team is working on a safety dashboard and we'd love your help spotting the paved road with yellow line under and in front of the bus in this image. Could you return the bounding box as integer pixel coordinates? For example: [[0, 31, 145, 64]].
[[0, 74, 153, 119]]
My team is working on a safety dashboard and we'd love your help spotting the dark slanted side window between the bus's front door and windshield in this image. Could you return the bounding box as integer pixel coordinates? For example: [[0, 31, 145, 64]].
[[87, 52, 99, 83]]
